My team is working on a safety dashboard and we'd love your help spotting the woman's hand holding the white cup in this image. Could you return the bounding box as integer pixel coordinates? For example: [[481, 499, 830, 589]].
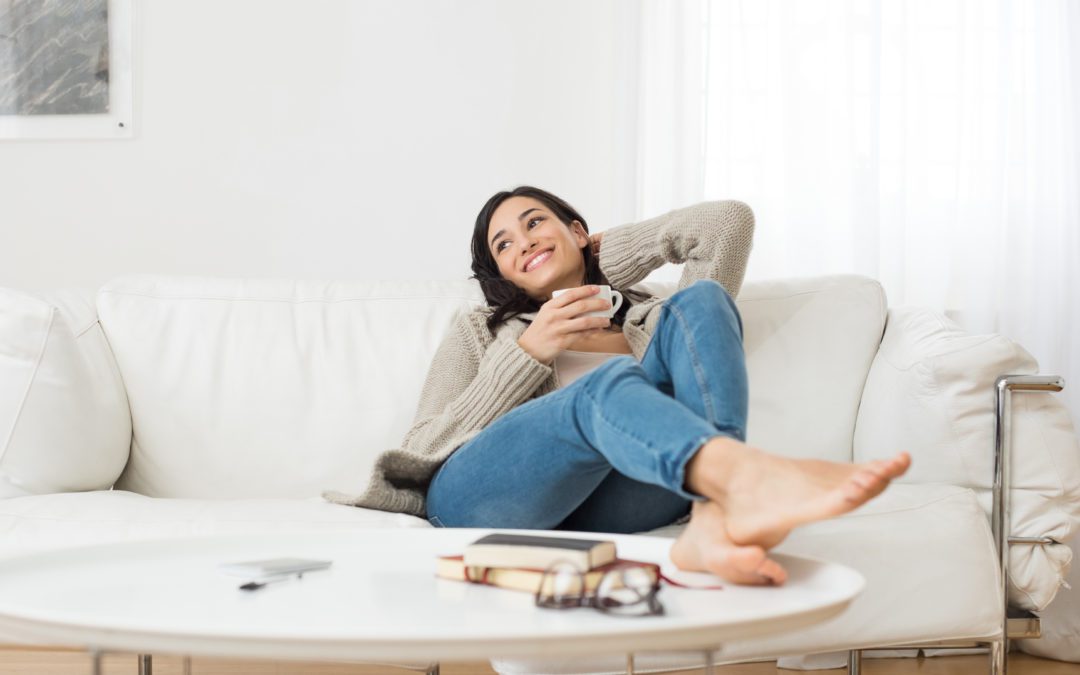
[[517, 285, 611, 365]]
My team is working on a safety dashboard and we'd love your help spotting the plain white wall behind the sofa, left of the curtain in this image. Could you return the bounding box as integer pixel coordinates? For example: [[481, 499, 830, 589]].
[[0, 0, 652, 289]]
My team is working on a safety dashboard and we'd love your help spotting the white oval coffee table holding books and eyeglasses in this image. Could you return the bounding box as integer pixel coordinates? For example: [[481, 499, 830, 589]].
[[0, 529, 864, 662]]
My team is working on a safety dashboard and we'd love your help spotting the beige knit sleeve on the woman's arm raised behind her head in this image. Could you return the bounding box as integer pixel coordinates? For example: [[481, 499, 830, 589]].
[[599, 200, 754, 297]]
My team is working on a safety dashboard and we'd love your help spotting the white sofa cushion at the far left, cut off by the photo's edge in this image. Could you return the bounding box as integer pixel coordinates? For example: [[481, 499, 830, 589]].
[[0, 288, 131, 498]]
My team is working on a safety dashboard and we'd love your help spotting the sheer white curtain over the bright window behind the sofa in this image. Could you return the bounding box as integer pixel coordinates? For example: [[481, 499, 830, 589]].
[[634, 0, 1080, 422]]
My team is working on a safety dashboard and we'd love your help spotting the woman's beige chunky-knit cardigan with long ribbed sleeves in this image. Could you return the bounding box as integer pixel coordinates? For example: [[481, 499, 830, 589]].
[[323, 201, 754, 517]]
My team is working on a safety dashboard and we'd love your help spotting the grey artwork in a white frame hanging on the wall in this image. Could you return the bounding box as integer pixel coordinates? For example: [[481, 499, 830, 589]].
[[0, 0, 135, 139]]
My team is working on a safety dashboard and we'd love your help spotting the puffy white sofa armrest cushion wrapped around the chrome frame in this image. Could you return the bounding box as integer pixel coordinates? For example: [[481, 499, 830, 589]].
[[853, 308, 1080, 610]]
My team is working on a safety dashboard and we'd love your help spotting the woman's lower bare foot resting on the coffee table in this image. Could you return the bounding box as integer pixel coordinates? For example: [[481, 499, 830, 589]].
[[671, 501, 787, 585]]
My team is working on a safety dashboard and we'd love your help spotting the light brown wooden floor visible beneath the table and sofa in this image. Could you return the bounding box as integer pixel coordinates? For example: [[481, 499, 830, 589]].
[[0, 647, 1080, 675]]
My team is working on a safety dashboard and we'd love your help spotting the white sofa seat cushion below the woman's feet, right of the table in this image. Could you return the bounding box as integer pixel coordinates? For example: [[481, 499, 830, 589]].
[[492, 485, 1001, 674]]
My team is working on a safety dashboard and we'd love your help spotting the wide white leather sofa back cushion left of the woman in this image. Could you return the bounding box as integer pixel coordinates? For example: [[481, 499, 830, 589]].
[[97, 276, 483, 498]]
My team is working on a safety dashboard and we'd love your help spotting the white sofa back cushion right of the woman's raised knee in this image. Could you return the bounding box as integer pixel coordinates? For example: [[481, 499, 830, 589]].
[[737, 274, 888, 462]]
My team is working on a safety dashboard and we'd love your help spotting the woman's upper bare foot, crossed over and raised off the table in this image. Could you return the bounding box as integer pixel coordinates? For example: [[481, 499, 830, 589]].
[[686, 436, 912, 549]]
